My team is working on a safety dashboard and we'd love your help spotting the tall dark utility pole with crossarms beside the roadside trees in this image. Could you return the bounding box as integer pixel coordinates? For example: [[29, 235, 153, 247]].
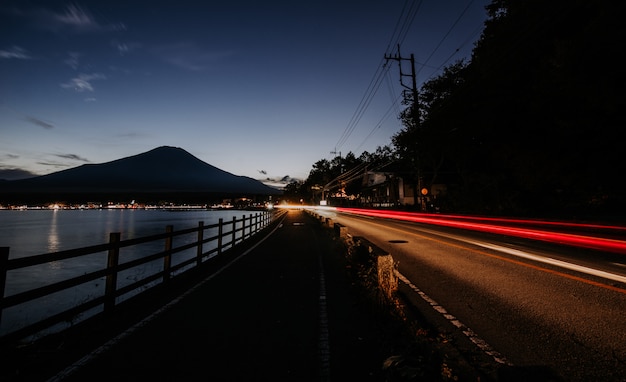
[[385, 44, 426, 211]]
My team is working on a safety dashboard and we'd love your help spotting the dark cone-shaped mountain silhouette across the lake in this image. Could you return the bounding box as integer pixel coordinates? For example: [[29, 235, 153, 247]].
[[0, 146, 280, 195]]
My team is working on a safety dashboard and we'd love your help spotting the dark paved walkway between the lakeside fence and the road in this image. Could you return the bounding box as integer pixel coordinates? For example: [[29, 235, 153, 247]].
[[36, 210, 391, 381]]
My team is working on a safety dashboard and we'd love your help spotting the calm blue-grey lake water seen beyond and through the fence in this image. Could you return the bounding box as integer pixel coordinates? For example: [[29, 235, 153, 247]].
[[0, 209, 255, 335]]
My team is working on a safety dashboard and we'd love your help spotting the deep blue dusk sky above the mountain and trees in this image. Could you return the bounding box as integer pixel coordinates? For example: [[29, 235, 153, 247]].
[[0, 0, 488, 184]]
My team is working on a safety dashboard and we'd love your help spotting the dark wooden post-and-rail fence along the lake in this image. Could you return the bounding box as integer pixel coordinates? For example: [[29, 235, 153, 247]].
[[0, 211, 281, 342]]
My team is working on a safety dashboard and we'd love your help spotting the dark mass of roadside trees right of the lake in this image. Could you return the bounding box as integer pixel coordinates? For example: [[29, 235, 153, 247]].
[[285, 0, 626, 219]]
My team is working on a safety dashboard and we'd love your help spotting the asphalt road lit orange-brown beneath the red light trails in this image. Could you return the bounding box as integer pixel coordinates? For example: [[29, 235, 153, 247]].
[[319, 211, 626, 381]]
